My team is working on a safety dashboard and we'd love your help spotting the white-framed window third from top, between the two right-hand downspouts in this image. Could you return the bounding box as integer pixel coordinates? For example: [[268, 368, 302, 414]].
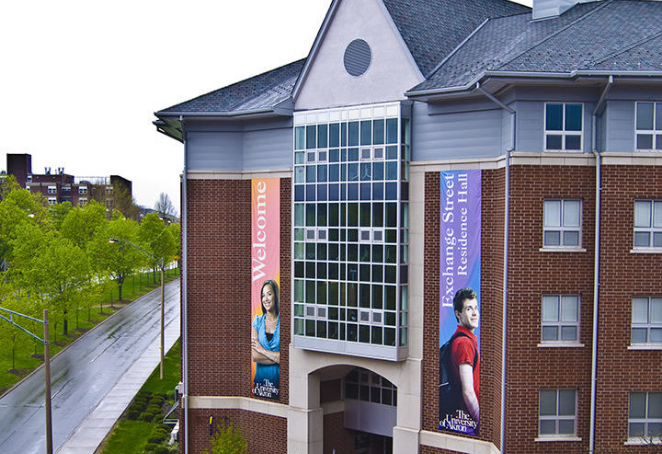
[[542, 295, 579, 343]]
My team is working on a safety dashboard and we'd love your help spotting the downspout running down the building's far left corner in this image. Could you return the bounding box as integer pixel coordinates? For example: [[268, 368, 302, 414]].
[[179, 115, 189, 454]]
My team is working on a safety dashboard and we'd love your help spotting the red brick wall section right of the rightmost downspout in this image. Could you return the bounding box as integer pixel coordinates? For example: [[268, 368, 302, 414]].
[[596, 166, 662, 453]]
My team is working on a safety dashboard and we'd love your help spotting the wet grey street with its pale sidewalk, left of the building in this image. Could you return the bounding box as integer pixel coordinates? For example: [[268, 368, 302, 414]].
[[0, 281, 180, 454]]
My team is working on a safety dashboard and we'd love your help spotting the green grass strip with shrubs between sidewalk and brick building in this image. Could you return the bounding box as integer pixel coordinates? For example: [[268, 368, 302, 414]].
[[97, 340, 181, 454]]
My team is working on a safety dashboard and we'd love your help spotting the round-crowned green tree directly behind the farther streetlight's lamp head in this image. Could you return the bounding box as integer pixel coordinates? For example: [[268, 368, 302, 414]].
[[88, 214, 146, 301]]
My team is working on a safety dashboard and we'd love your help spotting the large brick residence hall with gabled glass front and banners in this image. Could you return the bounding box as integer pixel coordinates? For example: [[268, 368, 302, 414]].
[[155, 0, 662, 454]]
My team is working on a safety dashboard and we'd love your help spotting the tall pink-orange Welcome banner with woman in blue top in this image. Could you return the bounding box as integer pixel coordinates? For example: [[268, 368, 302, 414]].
[[251, 178, 281, 400]]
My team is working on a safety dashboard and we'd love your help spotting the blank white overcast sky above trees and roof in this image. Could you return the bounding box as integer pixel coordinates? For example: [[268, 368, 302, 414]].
[[0, 0, 531, 211]]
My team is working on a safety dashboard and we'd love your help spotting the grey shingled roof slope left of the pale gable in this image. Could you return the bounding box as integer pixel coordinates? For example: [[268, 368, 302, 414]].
[[156, 60, 305, 116]]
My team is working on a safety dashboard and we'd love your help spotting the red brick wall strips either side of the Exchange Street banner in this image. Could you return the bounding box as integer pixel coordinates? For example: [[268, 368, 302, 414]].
[[421, 170, 505, 452]]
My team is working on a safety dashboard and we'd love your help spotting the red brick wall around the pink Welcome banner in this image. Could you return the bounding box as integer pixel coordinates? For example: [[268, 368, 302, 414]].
[[187, 179, 291, 446]]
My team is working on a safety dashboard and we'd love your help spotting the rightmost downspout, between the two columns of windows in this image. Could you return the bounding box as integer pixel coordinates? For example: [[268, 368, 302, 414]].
[[588, 76, 614, 454]]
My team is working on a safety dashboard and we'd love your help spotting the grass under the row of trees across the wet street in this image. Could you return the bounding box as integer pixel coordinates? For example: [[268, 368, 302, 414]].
[[0, 269, 179, 396]]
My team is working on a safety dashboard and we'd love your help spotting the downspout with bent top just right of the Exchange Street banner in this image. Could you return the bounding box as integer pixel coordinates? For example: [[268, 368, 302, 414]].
[[476, 84, 517, 454]]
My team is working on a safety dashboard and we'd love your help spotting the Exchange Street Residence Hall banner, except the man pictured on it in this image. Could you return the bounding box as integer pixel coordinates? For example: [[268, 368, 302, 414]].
[[439, 170, 482, 434]]
